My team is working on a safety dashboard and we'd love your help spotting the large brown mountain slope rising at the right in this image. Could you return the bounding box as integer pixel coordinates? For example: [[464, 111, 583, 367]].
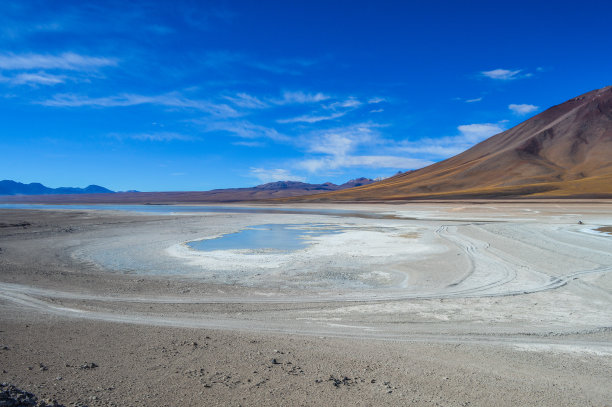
[[286, 86, 612, 201]]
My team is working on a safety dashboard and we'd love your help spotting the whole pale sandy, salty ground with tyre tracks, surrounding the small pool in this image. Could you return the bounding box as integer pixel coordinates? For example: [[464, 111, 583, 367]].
[[0, 206, 612, 406]]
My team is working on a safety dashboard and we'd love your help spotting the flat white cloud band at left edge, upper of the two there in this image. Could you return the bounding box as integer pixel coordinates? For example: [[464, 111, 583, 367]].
[[0, 52, 117, 71]]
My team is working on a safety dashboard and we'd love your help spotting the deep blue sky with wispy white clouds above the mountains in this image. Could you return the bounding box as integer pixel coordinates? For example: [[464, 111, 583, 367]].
[[0, 0, 612, 191]]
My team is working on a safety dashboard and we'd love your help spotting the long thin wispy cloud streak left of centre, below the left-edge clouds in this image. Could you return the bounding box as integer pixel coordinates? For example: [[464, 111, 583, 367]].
[[38, 93, 240, 117]]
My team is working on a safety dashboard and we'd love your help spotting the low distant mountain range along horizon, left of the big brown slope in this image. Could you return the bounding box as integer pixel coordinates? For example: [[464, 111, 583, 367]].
[[0, 178, 375, 204]]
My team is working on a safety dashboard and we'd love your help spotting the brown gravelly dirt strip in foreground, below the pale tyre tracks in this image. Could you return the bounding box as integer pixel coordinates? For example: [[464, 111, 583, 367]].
[[0, 315, 610, 406]]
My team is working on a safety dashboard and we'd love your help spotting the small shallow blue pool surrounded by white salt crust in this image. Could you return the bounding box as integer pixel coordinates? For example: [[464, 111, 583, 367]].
[[187, 224, 342, 251]]
